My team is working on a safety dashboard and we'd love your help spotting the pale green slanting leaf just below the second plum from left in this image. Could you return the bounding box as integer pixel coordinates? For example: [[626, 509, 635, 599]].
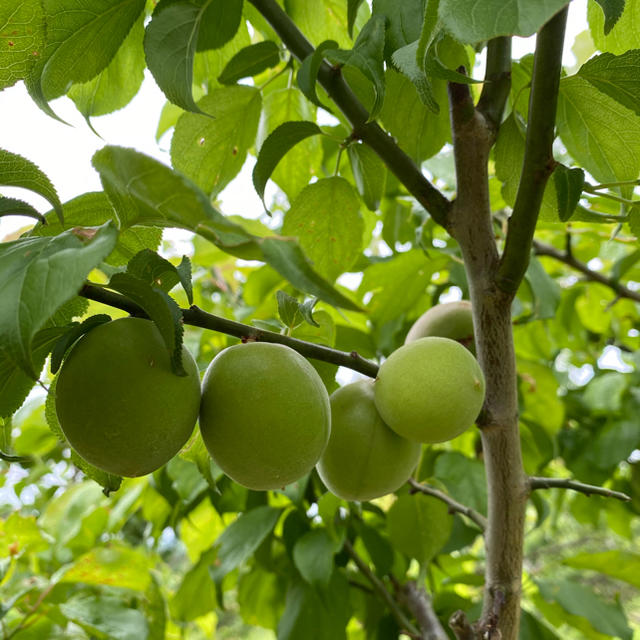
[[214, 505, 282, 577]]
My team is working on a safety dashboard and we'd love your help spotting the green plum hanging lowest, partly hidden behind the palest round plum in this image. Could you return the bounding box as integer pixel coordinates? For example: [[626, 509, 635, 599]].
[[317, 380, 421, 501]]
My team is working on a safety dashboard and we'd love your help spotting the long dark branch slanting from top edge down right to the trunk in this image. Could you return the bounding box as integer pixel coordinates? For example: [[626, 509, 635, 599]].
[[245, 0, 451, 226]]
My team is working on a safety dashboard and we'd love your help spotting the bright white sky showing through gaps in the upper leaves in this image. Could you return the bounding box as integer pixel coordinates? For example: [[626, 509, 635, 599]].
[[0, 0, 586, 240]]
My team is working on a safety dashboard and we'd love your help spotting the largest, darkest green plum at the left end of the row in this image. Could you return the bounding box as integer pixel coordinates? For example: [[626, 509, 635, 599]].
[[56, 318, 200, 477]]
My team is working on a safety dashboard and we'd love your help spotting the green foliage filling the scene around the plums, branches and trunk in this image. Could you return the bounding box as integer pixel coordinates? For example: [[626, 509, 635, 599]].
[[0, 0, 640, 640]]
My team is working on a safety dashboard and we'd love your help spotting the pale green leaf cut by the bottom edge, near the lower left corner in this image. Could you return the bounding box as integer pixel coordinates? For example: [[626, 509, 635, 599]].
[[58, 594, 149, 640]]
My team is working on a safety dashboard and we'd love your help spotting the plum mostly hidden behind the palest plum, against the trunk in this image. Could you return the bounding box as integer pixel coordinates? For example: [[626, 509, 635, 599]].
[[404, 300, 475, 353]]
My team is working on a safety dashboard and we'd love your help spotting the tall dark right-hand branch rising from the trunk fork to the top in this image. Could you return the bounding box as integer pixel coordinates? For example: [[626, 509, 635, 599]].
[[496, 7, 568, 295]]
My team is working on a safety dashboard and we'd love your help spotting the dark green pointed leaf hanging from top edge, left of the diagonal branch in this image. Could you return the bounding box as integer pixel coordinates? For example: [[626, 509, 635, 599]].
[[144, 0, 206, 113]]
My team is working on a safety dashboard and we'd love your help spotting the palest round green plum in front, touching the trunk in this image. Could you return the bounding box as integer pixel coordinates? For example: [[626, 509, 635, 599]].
[[374, 337, 484, 443]]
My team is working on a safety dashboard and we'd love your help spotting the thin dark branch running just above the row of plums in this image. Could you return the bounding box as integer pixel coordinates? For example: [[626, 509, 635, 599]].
[[79, 283, 378, 378]]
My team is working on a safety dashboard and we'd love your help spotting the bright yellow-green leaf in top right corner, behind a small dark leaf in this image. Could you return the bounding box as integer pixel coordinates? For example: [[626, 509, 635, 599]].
[[587, 0, 640, 55]]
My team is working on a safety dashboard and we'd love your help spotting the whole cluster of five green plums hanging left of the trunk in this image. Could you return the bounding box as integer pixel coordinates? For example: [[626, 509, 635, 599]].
[[56, 303, 484, 500]]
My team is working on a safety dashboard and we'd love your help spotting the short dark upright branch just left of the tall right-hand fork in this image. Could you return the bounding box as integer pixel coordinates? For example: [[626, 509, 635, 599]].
[[477, 36, 511, 131]]
